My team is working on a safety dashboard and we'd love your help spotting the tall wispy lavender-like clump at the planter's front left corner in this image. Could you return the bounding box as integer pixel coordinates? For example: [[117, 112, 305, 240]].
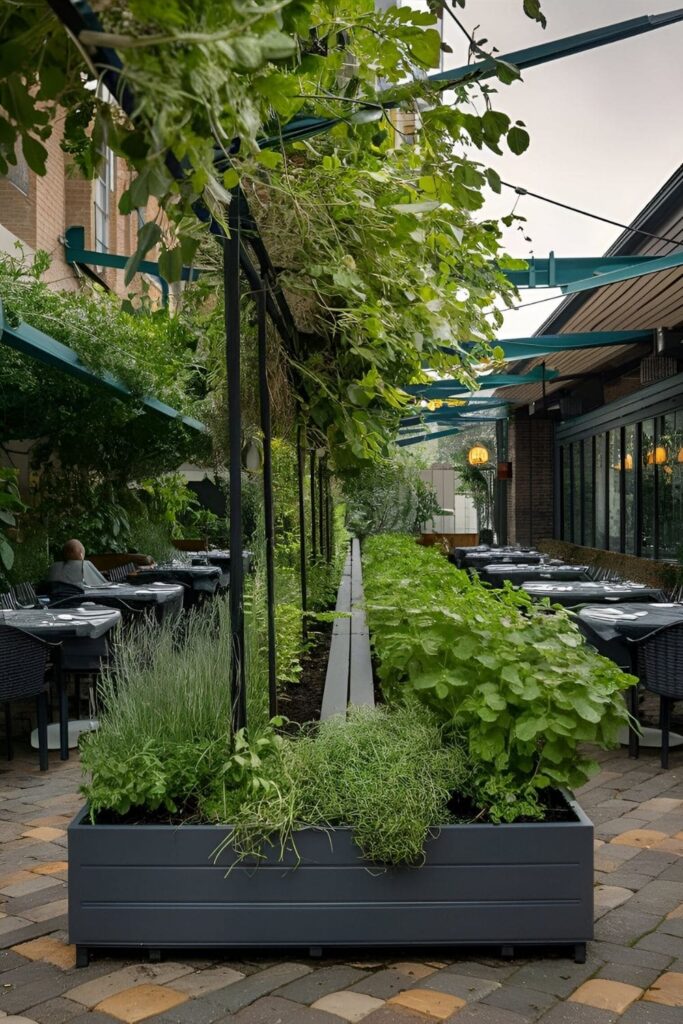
[[81, 598, 231, 819]]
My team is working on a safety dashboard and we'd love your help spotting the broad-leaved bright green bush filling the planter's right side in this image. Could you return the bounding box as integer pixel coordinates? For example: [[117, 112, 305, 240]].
[[365, 537, 635, 821]]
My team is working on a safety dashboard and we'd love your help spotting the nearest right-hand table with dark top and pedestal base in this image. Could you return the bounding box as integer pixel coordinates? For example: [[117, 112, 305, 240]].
[[579, 601, 683, 751]]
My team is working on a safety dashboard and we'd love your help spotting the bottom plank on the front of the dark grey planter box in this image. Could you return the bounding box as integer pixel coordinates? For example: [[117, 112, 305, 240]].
[[69, 900, 591, 948]]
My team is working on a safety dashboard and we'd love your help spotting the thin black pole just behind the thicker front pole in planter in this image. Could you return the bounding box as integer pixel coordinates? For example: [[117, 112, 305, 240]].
[[256, 285, 278, 718]]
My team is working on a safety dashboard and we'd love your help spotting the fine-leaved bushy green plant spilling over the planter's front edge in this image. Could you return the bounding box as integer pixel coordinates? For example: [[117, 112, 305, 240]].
[[202, 706, 469, 864]]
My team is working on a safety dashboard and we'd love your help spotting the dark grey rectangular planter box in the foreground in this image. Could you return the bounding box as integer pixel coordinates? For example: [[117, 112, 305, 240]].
[[69, 798, 593, 964]]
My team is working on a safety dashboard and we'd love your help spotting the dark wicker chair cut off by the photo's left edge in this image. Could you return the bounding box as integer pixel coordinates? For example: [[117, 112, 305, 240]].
[[0, 626, 47, 771]]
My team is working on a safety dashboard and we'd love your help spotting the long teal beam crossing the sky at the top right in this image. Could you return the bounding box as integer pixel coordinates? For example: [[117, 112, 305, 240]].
[[259, 8, 683, 150]]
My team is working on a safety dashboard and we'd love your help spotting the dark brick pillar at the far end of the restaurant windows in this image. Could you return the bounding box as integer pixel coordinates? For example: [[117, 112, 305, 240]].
[[508, 415, 553, 545]]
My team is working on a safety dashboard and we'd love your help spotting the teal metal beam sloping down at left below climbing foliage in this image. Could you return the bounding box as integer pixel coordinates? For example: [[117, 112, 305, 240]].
[[0, 301, 208, 433]]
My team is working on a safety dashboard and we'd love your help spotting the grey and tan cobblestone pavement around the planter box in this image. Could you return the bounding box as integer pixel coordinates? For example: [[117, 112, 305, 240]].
[[0, 751, 683, 1024]]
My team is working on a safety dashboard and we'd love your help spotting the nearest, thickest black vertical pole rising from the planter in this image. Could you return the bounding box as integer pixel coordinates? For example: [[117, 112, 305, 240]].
[[223, 201, 247, 732]]
